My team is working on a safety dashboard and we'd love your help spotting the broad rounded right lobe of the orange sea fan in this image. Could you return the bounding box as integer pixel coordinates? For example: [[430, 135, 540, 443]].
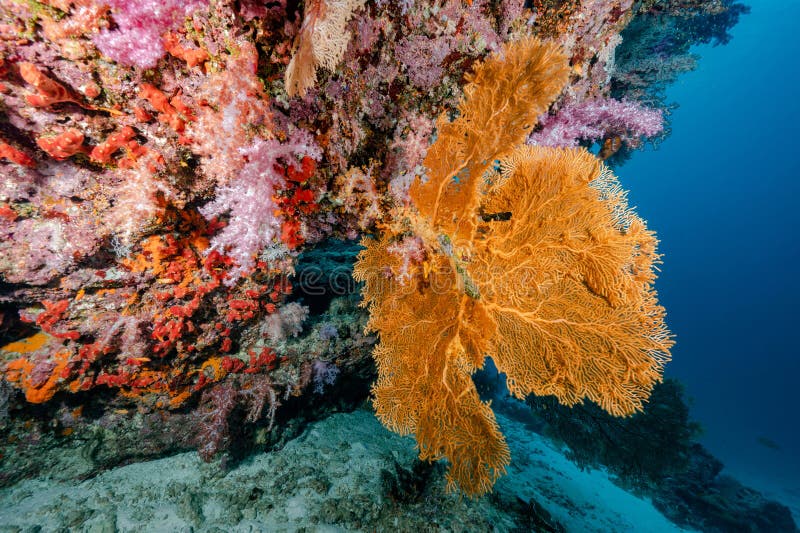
[[476, 146, 671, 415]]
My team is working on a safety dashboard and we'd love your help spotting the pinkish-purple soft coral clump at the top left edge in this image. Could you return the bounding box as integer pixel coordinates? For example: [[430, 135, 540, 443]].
[[94, 0, 208, 68]]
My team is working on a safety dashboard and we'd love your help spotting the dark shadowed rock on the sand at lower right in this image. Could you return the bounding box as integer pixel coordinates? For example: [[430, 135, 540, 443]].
[[524, 377, 797, 533]]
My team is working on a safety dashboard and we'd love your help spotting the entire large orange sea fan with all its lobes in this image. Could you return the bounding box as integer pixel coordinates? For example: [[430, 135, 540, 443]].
[[354, 39, 672, 495]]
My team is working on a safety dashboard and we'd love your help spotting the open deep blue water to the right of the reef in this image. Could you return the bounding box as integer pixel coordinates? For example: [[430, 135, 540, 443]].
[[619, 0, 800, 517]]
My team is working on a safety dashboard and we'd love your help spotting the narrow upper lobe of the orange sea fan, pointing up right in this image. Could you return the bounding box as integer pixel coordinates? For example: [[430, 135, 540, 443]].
[[409, 34, 569, 245]]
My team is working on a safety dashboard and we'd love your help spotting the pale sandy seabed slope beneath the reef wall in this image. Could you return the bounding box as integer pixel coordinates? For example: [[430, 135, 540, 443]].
[[0, 409, 680, 532]]
